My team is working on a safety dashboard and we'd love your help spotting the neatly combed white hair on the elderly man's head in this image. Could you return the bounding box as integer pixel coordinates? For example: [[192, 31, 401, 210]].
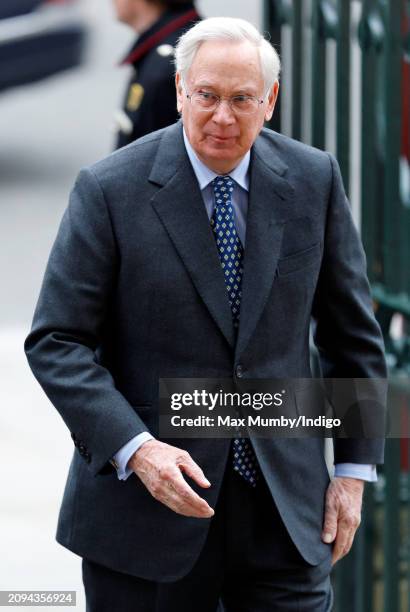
[[175, 17, 280, 92]]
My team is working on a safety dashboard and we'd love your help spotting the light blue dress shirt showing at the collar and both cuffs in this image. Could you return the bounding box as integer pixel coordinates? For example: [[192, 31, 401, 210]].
[[114, 130, 377, 482]]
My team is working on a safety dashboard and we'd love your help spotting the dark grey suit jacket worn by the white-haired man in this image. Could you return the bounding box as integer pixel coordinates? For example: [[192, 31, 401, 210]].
[[25, 123, 386, 581]]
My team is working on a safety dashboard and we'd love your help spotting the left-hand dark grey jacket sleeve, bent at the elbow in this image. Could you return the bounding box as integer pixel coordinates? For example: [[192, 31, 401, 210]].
[[24, 169, 147, 475]]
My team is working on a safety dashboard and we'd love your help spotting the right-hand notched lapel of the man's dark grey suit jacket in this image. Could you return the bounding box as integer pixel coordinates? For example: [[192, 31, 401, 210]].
[[235, 138, 294, 361]]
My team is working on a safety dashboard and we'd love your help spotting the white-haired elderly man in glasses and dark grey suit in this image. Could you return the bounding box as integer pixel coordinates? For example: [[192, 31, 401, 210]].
[[25, 18, 385, 612]]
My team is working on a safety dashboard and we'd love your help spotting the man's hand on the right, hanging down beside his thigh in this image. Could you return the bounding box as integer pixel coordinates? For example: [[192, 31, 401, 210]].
[[322, 477, 364, 565]]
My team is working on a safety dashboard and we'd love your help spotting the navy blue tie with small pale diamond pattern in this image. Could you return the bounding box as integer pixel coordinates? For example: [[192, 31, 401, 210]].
[[211, 176, 259, 487]]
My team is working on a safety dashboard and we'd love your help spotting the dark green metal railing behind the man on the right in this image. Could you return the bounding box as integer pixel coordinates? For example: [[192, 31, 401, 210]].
[[264, 0, 410, 612]]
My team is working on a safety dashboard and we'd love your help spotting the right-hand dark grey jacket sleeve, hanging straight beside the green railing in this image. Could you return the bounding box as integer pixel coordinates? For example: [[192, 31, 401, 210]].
[[312, 155, 387, 464]]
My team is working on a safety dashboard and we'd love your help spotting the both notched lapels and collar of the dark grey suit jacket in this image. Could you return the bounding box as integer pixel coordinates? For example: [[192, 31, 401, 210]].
[[149, 122, 293, 359]]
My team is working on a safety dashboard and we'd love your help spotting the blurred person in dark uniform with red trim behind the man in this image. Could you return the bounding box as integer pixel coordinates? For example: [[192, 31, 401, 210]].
[[114, 0, 200, 148]]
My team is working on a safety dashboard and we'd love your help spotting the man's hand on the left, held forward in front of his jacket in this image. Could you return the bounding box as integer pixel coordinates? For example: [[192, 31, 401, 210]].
[[128, 440, 215, 518]]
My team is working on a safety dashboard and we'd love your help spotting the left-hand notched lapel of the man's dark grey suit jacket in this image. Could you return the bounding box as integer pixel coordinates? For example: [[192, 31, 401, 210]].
[[149, 123, 235, 347]]
